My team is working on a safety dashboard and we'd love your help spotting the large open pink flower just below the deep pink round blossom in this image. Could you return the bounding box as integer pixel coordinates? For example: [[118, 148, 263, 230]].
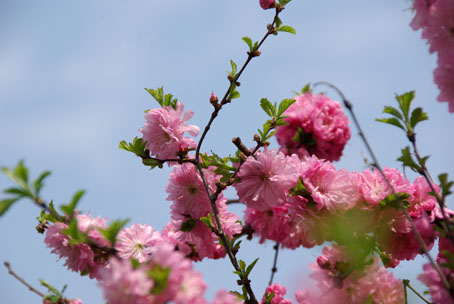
[[234, 148, 298, 211]]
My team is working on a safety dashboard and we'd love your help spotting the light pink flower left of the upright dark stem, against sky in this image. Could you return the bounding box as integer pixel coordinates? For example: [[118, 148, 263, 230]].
[[139, 102, 200, 159]]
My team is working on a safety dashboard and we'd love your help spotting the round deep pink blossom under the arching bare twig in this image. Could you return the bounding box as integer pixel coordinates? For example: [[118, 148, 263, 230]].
[[276, 92, 350, 161]]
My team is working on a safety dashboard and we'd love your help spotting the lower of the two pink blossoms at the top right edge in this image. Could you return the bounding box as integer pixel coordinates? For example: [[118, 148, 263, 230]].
[[434, 50, 454, 113]]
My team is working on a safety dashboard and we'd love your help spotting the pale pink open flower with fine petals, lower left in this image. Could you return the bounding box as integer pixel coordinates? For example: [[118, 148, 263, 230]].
[[115, 224, 161, 263]]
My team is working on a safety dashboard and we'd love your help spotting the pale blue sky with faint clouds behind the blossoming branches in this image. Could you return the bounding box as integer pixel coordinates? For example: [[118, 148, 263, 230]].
[[0, 0, 454, 303]]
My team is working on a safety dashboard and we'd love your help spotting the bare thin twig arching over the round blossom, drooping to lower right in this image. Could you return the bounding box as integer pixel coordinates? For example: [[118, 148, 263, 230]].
[[314, 81, 451, 292]]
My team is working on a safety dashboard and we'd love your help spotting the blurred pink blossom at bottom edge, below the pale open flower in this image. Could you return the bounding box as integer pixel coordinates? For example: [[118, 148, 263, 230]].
[[99, 258, 154, 304]]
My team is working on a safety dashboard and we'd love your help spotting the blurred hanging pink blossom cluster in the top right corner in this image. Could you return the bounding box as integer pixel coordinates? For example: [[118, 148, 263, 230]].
[[410, 0, 454, 112]]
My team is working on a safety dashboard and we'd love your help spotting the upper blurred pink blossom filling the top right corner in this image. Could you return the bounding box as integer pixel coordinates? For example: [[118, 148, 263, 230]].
[[422, 0, 454, 53]]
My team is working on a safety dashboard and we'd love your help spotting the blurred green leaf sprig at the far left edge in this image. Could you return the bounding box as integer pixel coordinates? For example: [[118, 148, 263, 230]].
[[0, 160, 50, 216]]
